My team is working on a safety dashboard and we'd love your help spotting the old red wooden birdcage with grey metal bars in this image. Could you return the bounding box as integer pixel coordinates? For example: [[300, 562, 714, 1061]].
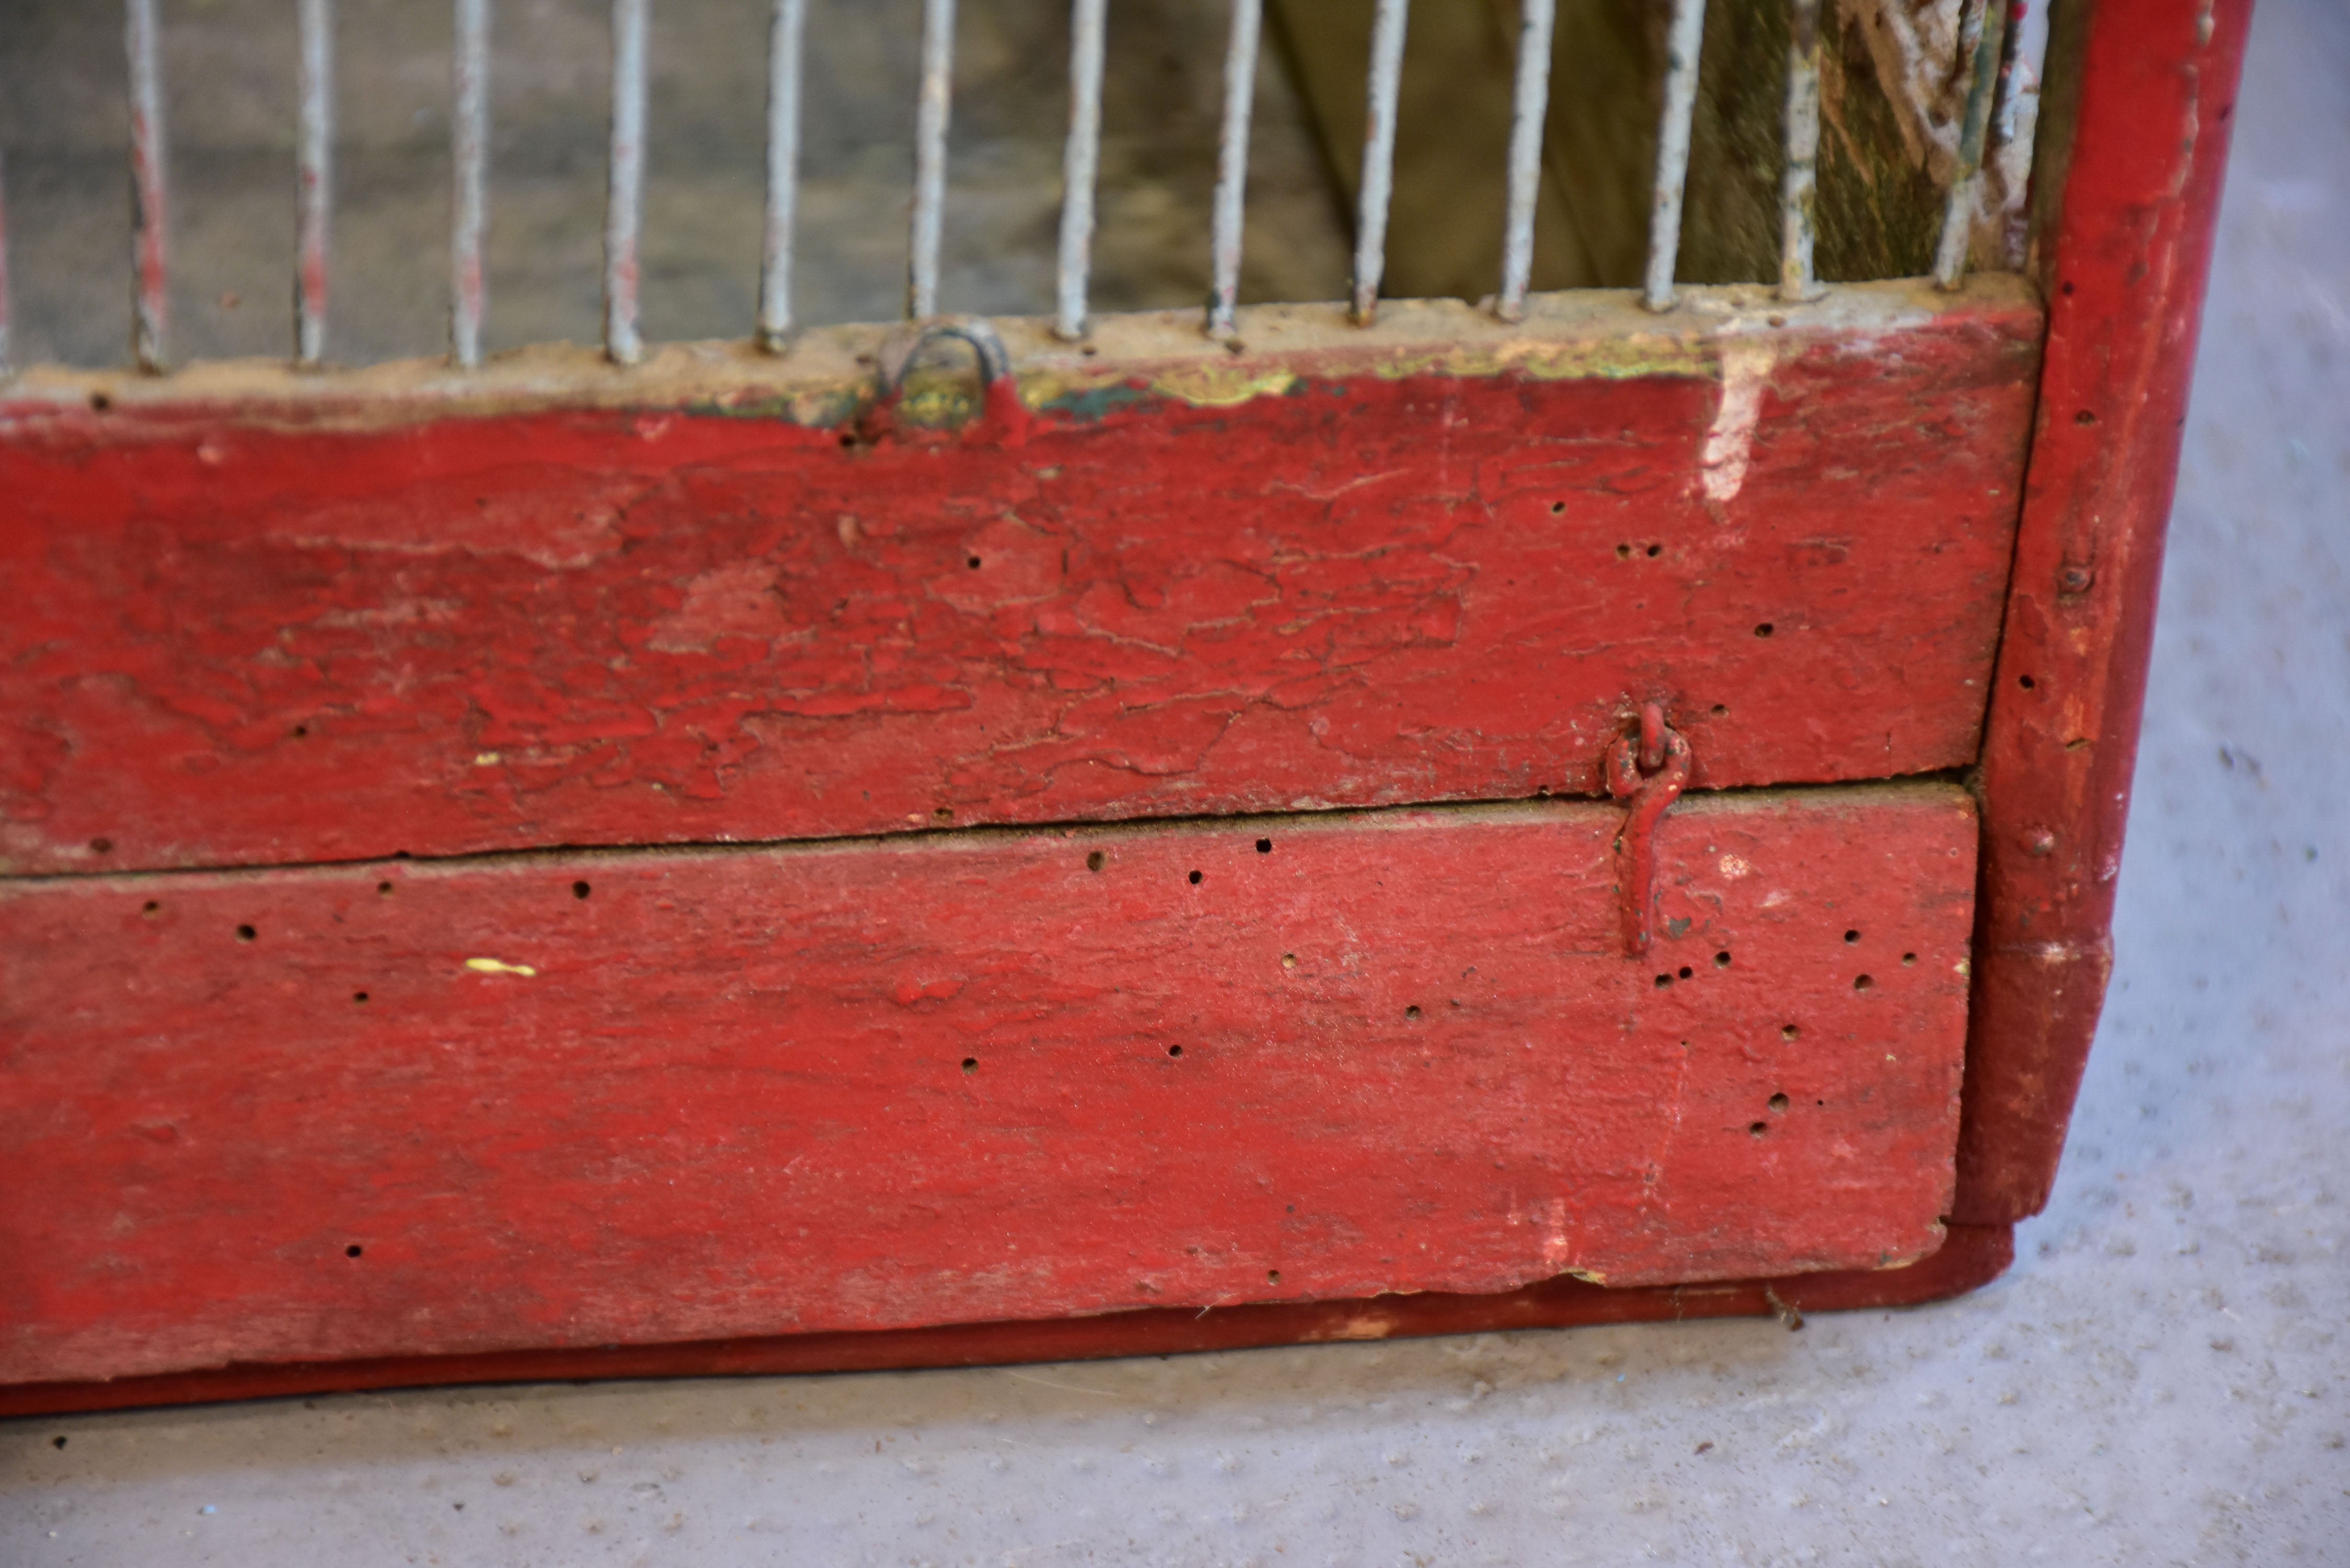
[[0, 0, 2249, 1411]]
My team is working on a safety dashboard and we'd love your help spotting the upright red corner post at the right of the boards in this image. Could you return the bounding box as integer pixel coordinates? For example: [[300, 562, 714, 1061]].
[[1955, 0, 2251, 1223]]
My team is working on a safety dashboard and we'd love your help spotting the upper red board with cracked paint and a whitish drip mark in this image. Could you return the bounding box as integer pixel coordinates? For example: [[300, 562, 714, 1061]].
[[0, 301, 2040, 872]]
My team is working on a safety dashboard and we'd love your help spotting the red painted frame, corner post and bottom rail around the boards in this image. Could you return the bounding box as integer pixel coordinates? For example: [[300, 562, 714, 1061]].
[[0, 0, 2251, 1413]]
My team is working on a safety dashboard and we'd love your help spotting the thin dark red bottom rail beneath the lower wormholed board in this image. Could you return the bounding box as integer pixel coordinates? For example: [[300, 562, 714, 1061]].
[[0, 1225, 2017, 1417]]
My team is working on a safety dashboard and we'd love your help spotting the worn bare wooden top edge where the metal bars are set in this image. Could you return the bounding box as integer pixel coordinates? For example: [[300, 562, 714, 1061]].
[[0, 273, 2040, 442]]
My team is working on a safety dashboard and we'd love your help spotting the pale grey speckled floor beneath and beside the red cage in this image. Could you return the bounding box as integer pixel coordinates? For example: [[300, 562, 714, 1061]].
[[0, 0, 2350, 1568]]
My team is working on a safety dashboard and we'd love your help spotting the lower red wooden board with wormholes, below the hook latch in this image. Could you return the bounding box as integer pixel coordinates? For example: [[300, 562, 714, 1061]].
[[0, 785, 1974, 1382]]
